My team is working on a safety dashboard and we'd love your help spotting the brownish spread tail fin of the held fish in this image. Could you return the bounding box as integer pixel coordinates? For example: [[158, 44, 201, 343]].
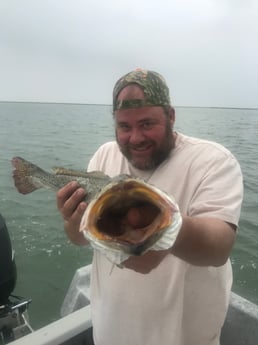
[[12, 157, 42, 194]]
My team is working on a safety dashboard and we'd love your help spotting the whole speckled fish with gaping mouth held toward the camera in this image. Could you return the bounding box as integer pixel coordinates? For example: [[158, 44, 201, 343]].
[[12, 157, 182, 267]]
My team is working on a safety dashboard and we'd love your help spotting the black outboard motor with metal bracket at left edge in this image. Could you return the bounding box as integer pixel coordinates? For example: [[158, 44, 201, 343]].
[[0, 214, 32, 345]]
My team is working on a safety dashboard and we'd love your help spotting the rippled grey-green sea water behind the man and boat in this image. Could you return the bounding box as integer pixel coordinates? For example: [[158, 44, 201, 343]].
[[0, 103, 258, 329]]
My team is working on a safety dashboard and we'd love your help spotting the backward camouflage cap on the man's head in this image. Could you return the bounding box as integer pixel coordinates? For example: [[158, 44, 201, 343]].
[[113, 69, 170, 111]]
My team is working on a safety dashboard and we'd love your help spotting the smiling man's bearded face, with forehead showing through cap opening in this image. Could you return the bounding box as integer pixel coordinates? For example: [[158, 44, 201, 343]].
[[114, 85, 174, 170]]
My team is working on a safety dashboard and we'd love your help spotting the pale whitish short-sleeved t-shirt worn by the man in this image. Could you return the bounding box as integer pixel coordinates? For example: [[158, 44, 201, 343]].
[[88, 133, 243, 345]]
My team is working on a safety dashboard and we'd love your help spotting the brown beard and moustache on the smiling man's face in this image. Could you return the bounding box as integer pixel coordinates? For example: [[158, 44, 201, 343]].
[[116, 121, 175, 170]]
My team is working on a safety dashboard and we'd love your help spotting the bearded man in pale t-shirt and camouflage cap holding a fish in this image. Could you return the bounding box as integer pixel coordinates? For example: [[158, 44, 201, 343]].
[[57, 70, 243, 345]]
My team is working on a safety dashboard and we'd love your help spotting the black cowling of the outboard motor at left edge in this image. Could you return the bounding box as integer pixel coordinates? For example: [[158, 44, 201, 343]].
[[0, 214, 17, 305]]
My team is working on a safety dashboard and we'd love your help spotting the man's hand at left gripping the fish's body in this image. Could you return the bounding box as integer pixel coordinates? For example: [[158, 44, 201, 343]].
[[56, 181, 88, 245]]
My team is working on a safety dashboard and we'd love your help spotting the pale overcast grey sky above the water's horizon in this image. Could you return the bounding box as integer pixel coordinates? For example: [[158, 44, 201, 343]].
[[0, 0, 258, 108]]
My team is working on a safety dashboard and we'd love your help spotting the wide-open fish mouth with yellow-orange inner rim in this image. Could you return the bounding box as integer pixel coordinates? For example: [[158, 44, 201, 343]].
[[80, 179, 175, 245]]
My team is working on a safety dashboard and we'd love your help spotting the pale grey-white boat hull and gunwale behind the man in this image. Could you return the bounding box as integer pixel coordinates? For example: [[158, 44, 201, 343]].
[[7, 265, 258, 345]]
